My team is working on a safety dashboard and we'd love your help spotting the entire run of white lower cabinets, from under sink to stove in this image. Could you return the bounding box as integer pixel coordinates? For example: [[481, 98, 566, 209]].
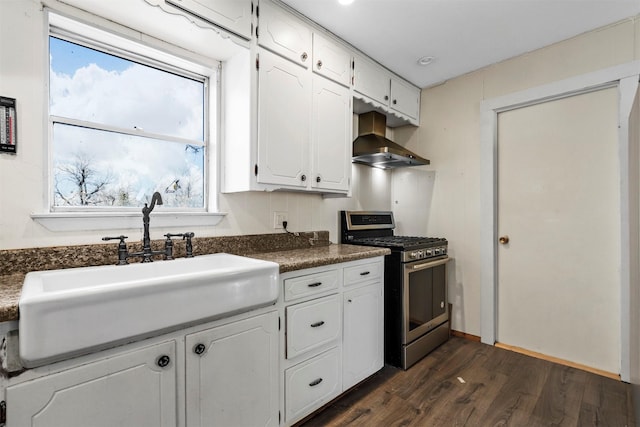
[[5, 256, 384, 427]]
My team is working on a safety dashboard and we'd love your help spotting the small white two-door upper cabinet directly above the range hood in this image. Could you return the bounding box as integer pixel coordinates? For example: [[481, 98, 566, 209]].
[[353, 55, 420, 126]]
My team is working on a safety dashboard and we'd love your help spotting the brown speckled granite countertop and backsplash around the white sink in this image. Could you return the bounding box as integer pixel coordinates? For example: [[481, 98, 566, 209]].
[[0, 232, 390, 322]]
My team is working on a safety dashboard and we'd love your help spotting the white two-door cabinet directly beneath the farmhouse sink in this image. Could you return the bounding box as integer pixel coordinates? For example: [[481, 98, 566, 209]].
[[5, 309, 280, 427]]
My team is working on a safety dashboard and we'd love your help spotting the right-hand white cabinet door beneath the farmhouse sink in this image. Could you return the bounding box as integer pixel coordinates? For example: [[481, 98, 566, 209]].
[[186, 311, 279, 426]]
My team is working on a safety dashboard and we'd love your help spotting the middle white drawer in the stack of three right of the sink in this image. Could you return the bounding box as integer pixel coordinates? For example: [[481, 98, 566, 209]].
[[285, 295, 342, 359]]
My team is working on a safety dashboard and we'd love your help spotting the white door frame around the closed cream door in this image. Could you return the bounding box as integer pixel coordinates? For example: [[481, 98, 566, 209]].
[[480, 61, 640, 382]]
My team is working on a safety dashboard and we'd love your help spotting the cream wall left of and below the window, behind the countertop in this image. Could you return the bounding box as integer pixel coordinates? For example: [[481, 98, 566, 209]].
[[0, 0, 391, 249]]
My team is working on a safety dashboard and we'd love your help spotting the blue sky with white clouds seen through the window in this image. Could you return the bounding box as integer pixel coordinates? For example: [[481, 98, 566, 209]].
[[50, 37, 205, 207]]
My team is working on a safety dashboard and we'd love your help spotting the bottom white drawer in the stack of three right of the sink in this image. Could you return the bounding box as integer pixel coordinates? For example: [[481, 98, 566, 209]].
[[285, 348, 342, 424]]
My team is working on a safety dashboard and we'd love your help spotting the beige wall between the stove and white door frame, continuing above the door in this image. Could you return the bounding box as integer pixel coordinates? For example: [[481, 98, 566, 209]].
[[395, 17, 640, 335]]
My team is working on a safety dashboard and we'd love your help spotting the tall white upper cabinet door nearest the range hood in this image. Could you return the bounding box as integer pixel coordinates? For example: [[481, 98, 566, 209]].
[[311, 75, 353, 192]]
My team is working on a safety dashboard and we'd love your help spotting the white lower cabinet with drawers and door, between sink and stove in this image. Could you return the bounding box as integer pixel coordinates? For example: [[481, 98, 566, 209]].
[[281, 257, 384, 426]]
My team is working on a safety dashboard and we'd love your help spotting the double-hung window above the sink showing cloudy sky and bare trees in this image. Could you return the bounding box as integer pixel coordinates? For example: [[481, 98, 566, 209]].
[[49, 16, 217, 212]]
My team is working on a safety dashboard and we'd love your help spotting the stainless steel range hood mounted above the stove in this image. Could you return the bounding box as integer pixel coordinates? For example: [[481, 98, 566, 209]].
[[352, 111, 430, 169]]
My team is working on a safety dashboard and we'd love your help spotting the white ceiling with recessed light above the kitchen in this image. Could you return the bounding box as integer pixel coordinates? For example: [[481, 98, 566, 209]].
[[282, 0, 640, 88]]
